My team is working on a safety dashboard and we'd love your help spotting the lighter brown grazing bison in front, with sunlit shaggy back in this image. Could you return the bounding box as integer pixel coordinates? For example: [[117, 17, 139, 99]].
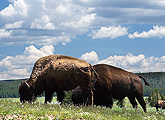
[[19, 55, 97, 103]]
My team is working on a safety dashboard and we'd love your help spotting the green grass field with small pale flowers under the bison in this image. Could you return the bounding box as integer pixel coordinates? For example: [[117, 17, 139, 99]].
[[0, 97, 165, 120]]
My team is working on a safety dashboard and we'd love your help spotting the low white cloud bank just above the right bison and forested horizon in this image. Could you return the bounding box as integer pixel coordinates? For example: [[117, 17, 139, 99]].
[[97, 53, 165, 72]]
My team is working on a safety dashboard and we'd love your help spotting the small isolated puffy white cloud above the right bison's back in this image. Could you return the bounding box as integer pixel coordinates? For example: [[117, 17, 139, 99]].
[[92, 26, 128, 39]]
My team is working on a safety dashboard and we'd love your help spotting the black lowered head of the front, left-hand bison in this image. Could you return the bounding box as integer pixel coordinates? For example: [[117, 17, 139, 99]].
[[18, 81, 33, 102]]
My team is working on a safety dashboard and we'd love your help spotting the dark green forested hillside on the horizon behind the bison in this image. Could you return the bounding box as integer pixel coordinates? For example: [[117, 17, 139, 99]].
[[0, 72, 165, 98]]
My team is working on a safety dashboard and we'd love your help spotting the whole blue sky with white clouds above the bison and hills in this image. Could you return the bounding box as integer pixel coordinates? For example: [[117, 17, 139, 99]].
[[0, 0, 165, 80]]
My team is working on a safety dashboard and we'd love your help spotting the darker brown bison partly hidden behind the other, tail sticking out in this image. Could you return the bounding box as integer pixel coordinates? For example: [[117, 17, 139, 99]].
[[72, 64, 149, 112]]
